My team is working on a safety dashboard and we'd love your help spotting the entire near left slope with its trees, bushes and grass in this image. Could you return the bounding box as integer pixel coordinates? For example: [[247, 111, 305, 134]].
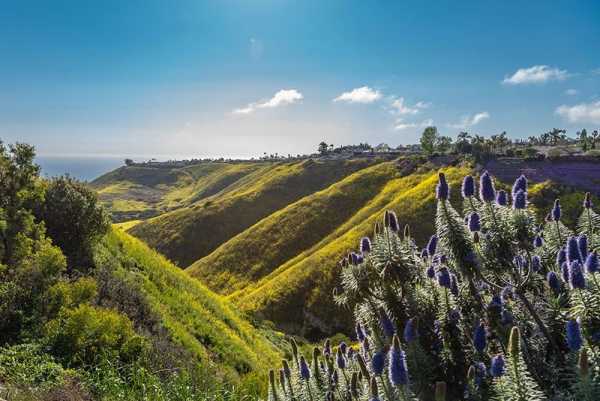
[[0, 144, 279, 401]]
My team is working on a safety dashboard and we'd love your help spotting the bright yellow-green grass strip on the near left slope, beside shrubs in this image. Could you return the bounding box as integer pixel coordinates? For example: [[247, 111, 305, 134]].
[[98, 230, 278, 382]]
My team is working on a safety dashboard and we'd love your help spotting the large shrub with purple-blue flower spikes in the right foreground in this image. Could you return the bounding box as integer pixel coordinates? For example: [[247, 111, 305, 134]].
[[269, 172, 600, 401]]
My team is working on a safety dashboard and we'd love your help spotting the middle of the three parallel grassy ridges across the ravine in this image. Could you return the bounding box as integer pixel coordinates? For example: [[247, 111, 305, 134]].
[[187, 162, 398, 294]]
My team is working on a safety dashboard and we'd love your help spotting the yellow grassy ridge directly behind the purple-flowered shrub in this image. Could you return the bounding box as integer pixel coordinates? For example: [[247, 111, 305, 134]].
[[230, 167, 468, 338]]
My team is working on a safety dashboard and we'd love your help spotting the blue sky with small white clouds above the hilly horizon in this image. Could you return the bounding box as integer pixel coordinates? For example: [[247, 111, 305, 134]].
[[0, 0, 600, 159]]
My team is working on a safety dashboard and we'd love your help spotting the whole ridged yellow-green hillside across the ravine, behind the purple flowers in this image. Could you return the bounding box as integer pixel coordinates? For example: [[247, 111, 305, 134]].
[[94, 157, 600, 339]]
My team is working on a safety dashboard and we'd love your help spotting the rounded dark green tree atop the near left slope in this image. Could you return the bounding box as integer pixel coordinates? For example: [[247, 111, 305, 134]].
[[39, 176, 110, 271]]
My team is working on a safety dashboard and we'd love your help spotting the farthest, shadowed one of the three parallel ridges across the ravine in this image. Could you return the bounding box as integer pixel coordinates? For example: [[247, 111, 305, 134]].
[[130, 160, 373, 266]]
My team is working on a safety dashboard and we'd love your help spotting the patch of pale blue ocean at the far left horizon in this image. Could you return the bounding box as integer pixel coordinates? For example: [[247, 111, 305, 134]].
[[35, 156, 125, 181]]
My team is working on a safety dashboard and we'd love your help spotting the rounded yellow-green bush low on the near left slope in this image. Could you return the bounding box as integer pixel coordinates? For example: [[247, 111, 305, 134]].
[[46, 305, 146, 366]]
